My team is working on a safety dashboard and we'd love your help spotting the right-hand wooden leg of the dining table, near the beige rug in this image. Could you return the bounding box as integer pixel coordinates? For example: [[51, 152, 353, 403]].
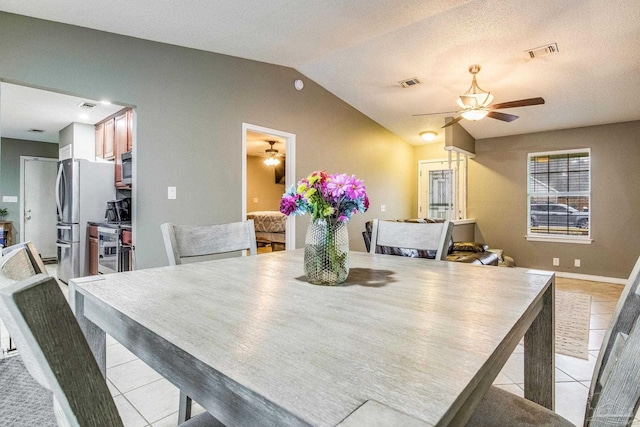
[[524, 276, 555, 411]]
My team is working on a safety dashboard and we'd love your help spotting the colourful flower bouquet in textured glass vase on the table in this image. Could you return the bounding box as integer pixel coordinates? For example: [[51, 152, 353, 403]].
[[280, 171, 369, 285]]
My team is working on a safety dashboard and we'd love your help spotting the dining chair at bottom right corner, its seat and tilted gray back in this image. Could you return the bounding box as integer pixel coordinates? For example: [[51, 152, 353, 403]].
[[467, 258, 640, 427]]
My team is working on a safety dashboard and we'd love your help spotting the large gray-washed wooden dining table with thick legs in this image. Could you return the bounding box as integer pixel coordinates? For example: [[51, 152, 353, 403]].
[[69, 249, 555, 427]]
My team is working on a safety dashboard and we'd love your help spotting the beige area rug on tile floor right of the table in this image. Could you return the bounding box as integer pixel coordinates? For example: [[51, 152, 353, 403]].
[[555, 291, 591, 360]]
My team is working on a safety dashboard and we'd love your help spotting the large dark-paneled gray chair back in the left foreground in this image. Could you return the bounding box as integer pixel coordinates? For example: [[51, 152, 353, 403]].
[[0, 274, 123, 427]]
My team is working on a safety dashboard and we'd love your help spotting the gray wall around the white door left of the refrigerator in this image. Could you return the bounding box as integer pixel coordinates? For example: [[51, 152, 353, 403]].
[[0, 138, 58, 234]]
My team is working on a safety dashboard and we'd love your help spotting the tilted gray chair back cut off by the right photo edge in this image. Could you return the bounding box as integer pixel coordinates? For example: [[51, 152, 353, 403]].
[[585, 258, 640, 426]]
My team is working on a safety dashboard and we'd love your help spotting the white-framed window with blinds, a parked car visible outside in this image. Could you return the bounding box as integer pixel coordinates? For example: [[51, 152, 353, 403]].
[[527, 149, 591, 243]]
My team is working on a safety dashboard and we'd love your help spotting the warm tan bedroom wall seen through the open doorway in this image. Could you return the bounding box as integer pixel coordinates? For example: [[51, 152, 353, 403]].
[[247, 156, 285, 212]]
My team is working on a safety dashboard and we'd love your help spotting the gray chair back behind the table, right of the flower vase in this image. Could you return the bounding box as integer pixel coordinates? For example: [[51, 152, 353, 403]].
[[369, 219, 453, 260]]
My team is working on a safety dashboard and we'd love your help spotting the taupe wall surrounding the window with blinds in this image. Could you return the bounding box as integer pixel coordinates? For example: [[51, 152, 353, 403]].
[[467, 121, 640, 278]]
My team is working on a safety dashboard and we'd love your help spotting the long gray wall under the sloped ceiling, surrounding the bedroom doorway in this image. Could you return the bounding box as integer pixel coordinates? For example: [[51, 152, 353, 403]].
[[0, 13, 416, 267]]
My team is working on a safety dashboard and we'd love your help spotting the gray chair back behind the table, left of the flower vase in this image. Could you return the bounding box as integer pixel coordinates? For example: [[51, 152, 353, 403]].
[[161, 219, 258, 265]]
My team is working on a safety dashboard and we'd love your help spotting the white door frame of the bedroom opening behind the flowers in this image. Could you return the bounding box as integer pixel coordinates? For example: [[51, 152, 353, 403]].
[[242, 123, 296, 251]]
